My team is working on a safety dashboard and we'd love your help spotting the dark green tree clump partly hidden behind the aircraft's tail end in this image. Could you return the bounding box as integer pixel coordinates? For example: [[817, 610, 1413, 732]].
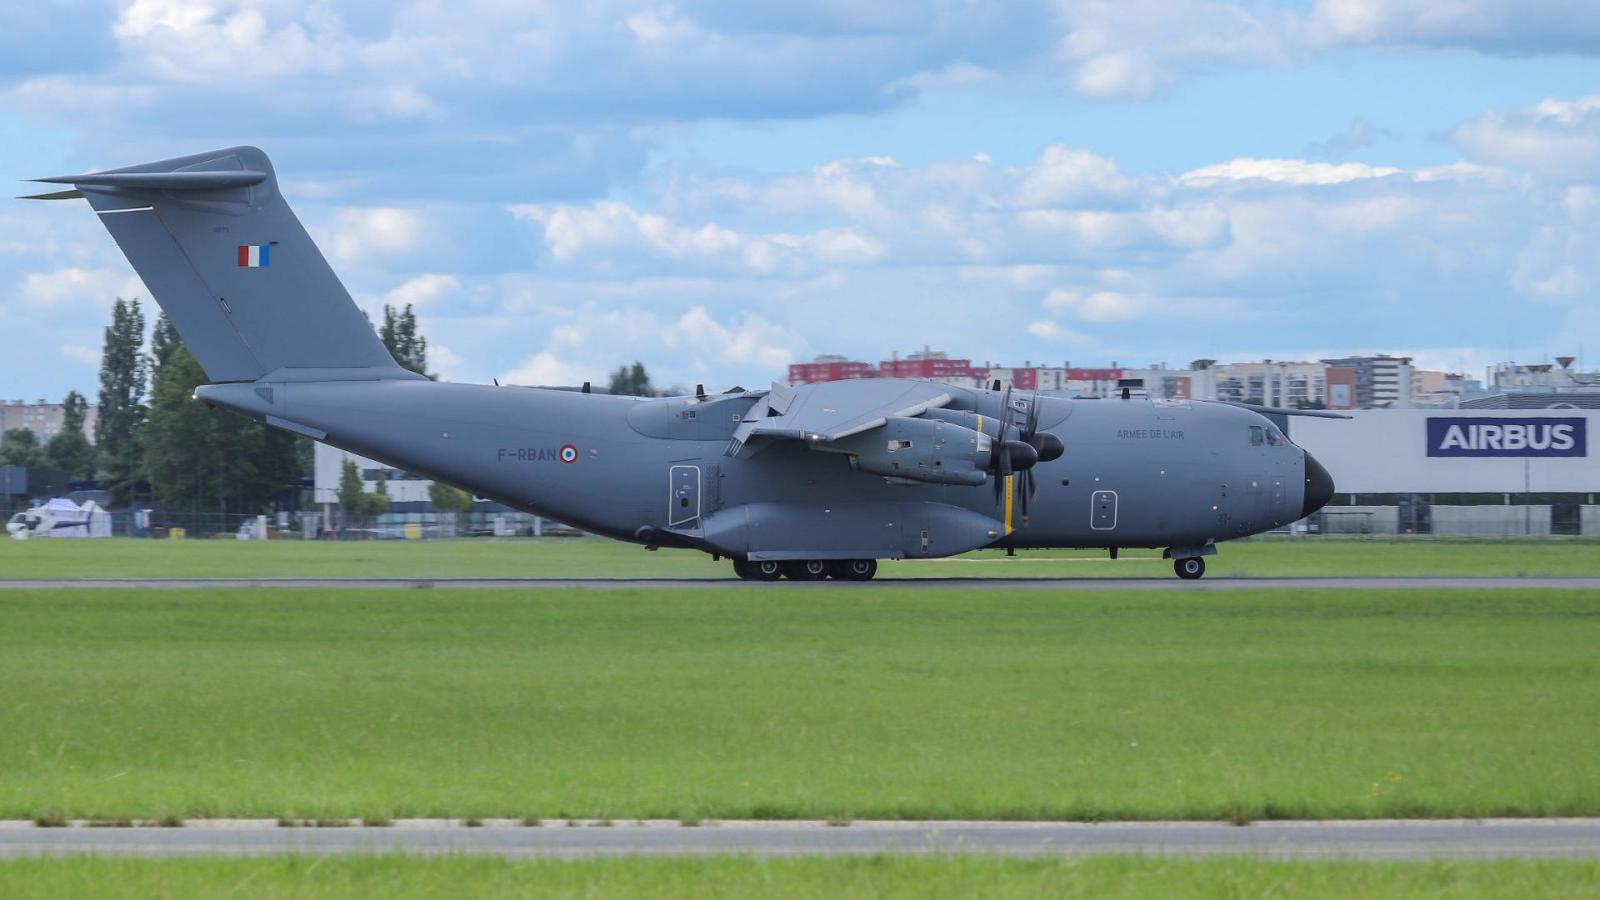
[[142, 317, 304, 516]]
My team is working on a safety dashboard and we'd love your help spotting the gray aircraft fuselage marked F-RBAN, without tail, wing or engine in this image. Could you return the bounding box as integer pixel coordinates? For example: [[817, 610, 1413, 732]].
[[197, 373, 1326, 559]]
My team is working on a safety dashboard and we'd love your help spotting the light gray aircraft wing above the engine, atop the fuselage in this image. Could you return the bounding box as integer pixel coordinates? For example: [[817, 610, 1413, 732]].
[[726, 378, 950, 456]]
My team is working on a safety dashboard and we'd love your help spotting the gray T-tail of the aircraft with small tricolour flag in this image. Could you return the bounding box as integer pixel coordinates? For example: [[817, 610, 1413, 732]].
[[30, 147, 421, 383]]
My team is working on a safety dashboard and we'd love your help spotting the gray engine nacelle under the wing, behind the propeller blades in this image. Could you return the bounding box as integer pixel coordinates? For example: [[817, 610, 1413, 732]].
[[816, 416, 990, 485]]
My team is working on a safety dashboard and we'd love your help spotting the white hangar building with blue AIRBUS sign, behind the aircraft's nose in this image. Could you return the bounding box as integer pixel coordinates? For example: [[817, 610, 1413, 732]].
[[1286, 408, 1600, 535]]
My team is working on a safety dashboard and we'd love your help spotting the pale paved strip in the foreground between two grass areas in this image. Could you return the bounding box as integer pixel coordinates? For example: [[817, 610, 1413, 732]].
[[0, 818, 1600, 858]]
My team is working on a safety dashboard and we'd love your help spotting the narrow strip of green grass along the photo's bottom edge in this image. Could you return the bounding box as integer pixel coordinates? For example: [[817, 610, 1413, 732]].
[[0, 857, 1600, 900]]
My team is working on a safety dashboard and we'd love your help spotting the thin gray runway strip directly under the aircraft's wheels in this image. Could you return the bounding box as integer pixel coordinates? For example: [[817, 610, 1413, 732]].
[[0, 577, 1600, 591]]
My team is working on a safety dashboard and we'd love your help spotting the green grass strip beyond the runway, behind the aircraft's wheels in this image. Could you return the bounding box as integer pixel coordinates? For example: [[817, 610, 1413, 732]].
[[0, 538, 1600, 580]]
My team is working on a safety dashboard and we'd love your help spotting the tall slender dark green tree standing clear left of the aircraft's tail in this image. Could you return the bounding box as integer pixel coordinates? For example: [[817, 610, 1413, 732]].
[[94, 296, 149, 504]]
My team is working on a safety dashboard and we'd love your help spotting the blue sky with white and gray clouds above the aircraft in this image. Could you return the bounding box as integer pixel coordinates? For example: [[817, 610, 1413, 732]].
[[0, 0, 1600, 399]]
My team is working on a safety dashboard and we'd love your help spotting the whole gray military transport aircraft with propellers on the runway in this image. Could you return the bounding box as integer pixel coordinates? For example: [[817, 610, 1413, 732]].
[[29, 147, 1333, 580]]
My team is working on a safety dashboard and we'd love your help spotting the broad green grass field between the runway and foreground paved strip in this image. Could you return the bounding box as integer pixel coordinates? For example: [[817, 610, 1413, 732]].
[[0, 586, 1600, 820]]
